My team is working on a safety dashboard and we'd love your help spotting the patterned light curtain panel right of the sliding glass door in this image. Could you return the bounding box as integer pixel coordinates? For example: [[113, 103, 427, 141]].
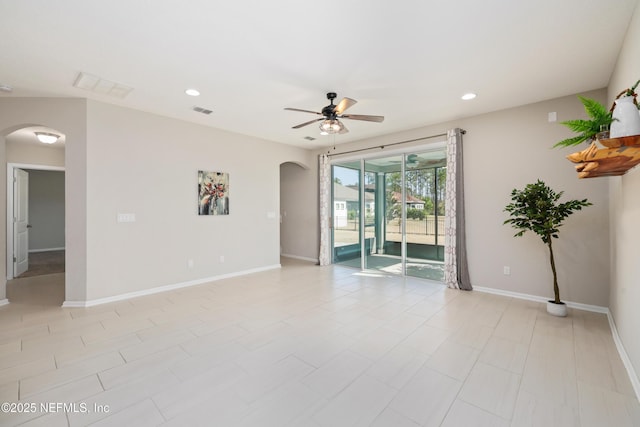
[[444, 128, 472, 291]]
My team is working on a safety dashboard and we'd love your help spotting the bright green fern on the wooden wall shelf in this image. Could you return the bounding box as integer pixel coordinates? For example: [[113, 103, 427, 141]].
[[554, 96, 615, 148]]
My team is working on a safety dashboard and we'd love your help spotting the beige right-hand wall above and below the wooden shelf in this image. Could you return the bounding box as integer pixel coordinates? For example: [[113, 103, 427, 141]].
[[608, 0, 640, 388]]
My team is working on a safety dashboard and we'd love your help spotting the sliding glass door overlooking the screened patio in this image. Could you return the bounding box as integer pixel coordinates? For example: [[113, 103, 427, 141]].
[[332, 149, 446, 281]]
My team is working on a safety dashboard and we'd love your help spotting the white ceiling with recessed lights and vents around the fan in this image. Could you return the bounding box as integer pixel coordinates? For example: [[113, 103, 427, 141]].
[[0, 0, 638, 148]]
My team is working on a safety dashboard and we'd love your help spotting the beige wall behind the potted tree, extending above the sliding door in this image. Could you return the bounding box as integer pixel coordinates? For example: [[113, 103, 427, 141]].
[[314, 90, 609, 307]]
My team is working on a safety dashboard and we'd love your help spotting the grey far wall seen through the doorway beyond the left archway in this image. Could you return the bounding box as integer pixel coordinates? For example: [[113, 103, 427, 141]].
[[26, 169, 64, 251]]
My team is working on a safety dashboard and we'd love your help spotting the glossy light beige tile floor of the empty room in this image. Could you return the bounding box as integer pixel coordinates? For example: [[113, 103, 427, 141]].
[[0, 259, 640, 427]]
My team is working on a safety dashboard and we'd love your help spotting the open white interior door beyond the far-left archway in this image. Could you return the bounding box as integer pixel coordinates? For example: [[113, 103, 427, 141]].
[[13, 168, 29, 277]]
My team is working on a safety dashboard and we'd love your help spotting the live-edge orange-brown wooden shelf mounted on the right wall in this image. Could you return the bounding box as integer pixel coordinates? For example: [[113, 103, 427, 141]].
[[567, 135, 640, 178]]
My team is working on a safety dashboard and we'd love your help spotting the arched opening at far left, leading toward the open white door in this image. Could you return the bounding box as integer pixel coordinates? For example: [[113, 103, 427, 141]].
[[5, 125, 65, 306]]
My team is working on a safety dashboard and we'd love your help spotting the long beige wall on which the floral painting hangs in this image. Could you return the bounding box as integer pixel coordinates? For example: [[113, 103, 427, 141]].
[[87, 101, 310, 300]]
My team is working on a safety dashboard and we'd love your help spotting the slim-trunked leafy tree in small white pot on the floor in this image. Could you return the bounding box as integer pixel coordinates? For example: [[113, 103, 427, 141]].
[[504, 180, 592, 316]]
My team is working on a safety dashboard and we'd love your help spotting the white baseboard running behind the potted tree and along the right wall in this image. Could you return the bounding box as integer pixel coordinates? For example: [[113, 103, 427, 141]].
[[473, 286, 640, 402]]
